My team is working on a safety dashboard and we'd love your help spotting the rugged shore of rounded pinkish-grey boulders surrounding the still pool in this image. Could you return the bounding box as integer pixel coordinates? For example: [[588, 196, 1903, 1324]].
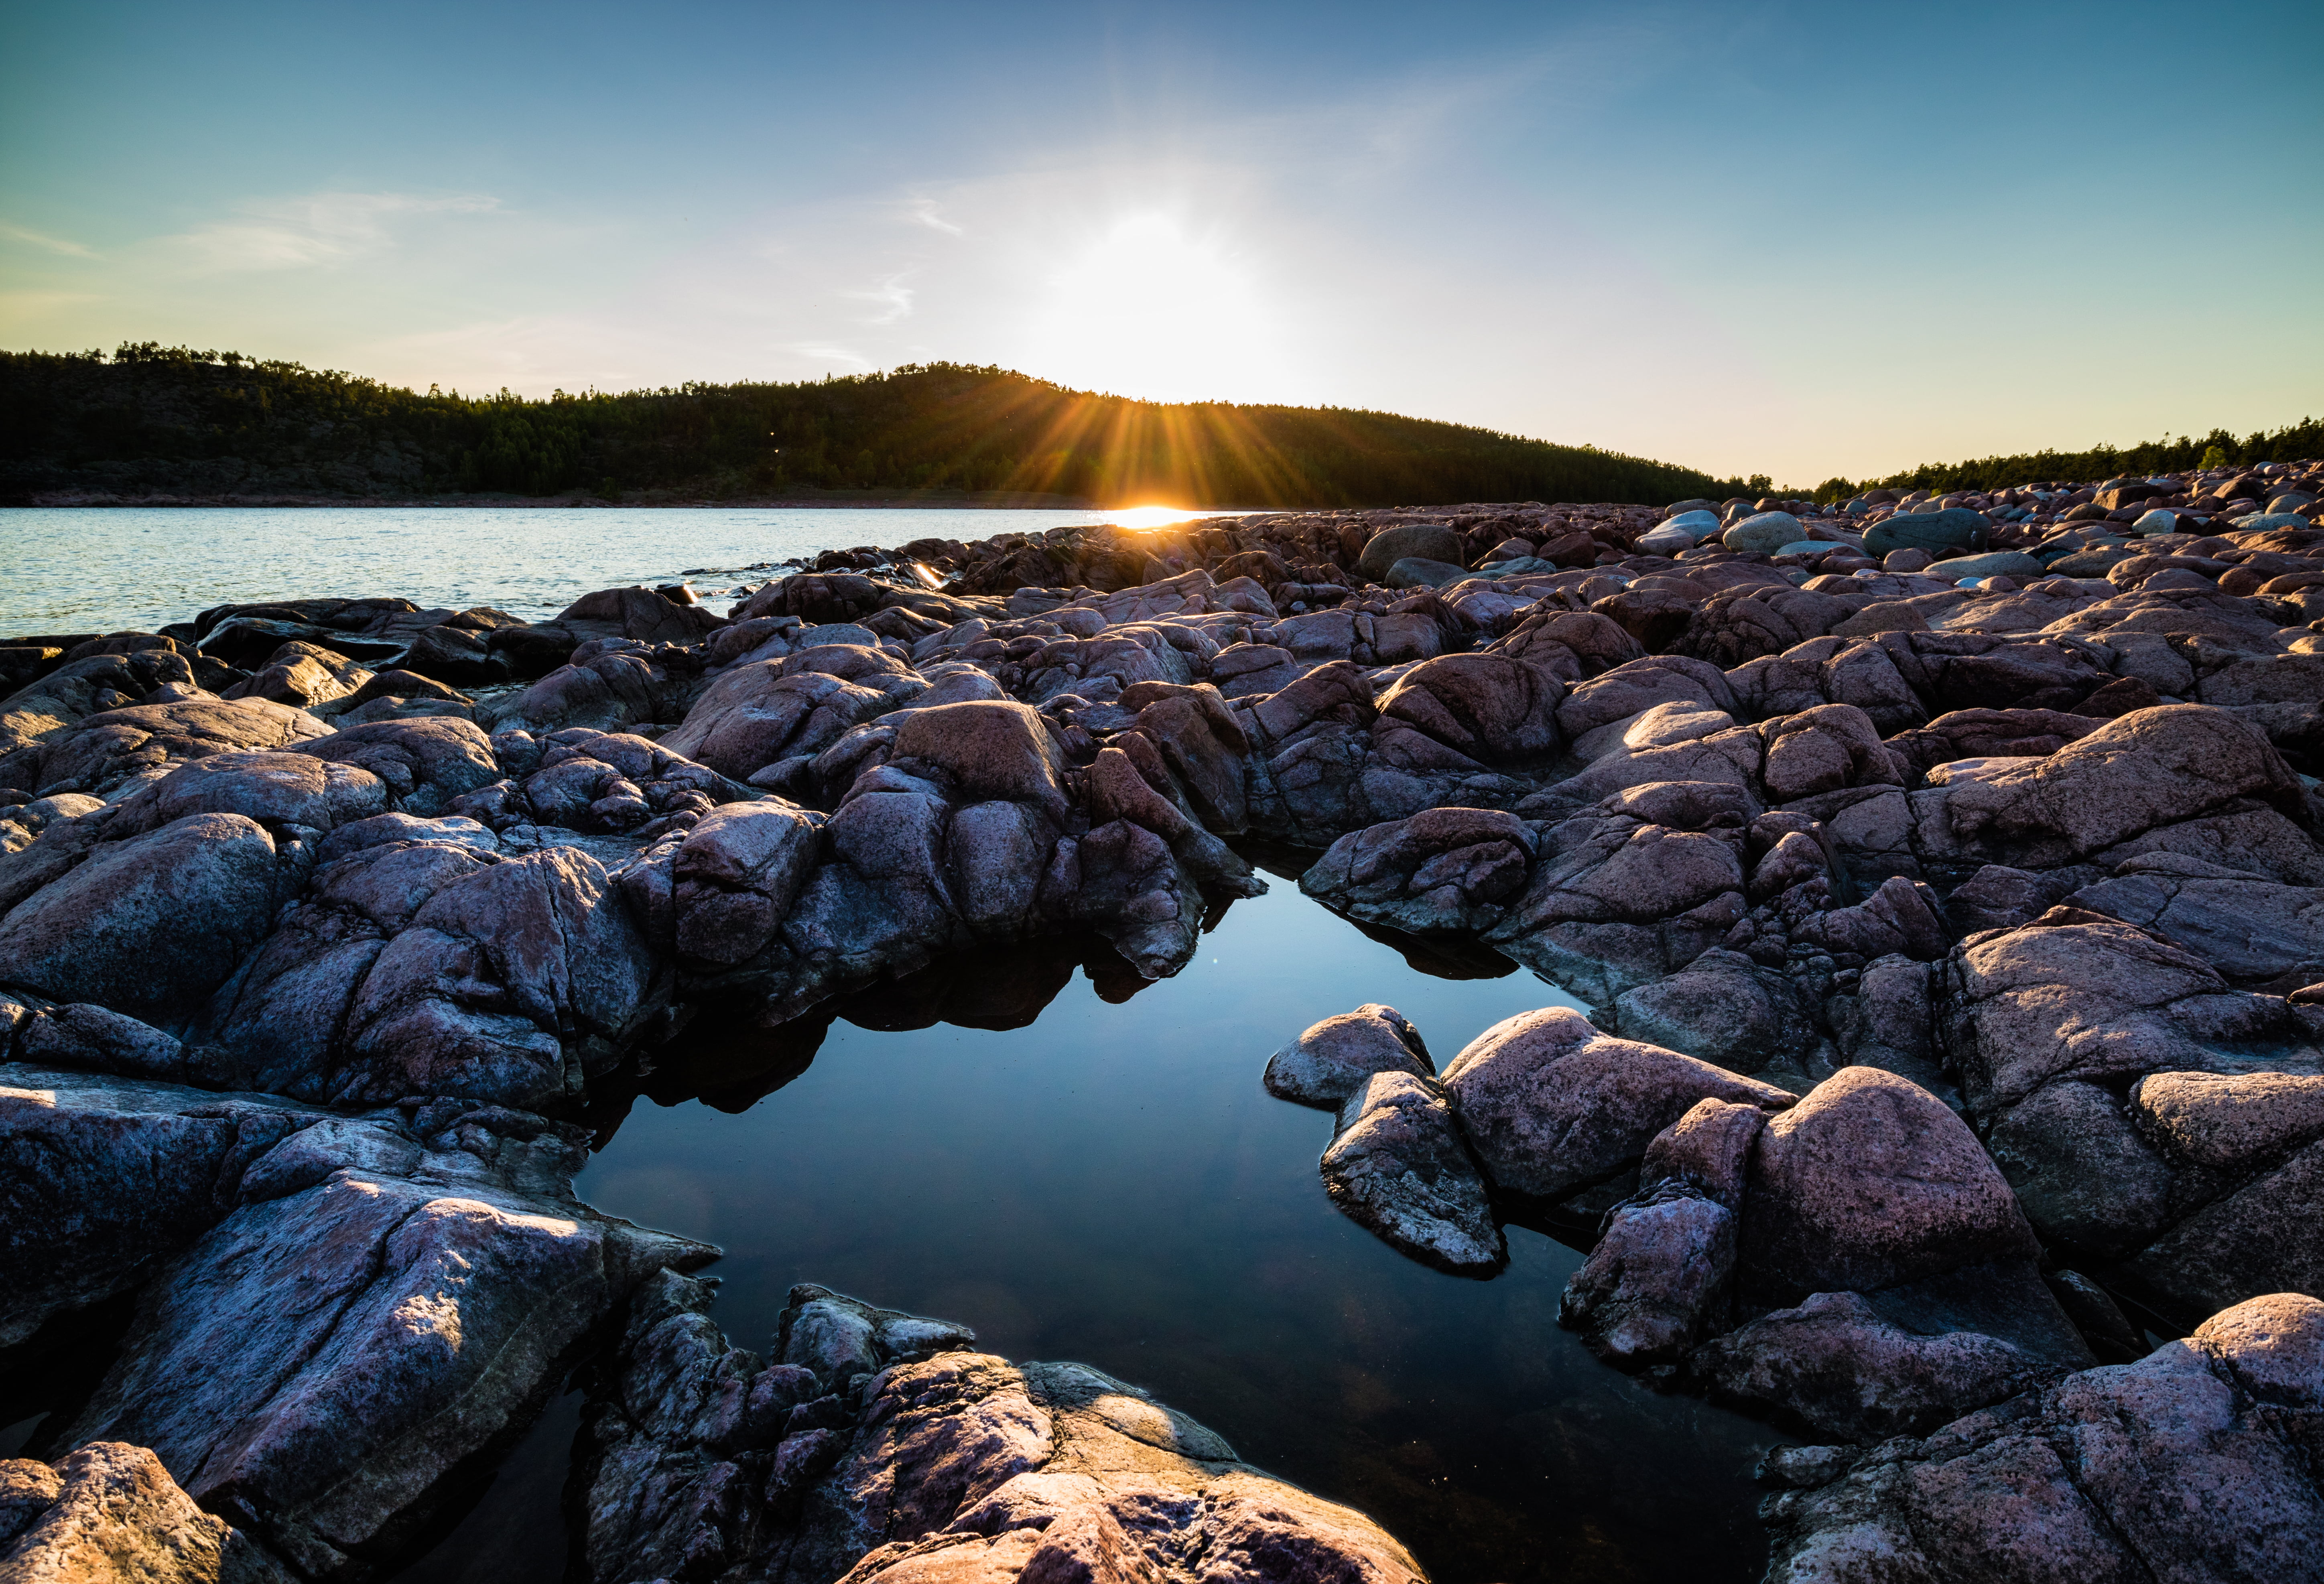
[[0, 451, 2324, 1584]]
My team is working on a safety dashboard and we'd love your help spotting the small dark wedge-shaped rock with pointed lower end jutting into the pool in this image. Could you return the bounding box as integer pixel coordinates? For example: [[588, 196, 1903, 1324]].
[[1322, 1071, 1508, 1275]]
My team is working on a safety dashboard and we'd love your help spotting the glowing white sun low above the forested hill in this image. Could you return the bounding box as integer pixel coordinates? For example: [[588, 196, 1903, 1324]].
[[1036, 214, 1278, 402]]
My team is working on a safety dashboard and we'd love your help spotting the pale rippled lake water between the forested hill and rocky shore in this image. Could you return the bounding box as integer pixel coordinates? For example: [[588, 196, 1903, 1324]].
[[0, 506, 1171, 634]]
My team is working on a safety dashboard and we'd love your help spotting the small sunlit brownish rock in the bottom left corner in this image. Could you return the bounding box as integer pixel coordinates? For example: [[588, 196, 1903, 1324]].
[[0, 1440, 297, 1584]]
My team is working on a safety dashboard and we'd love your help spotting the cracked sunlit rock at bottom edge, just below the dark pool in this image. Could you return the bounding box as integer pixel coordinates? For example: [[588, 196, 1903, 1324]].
[[581, 1284, 1422, 1584]]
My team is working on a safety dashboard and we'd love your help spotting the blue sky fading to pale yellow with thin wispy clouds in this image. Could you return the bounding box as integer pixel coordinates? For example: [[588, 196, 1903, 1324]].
[[0, 0, 2324, 485]]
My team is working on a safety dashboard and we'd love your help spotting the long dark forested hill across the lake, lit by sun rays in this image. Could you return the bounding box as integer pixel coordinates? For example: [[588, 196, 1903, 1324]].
[[0, 344, 1766, 506]]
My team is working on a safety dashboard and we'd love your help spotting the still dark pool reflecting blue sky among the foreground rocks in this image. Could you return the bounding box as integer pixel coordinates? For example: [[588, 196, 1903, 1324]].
[[404, 880, 1778, 1584]]
